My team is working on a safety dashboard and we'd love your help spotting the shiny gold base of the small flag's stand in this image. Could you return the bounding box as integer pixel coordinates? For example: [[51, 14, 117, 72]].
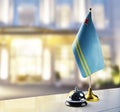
[[85, 88, 99, 102]]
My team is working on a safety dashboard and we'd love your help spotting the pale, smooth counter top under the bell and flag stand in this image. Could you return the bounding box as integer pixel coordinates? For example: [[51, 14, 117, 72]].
[[0, 88, 120, 112]]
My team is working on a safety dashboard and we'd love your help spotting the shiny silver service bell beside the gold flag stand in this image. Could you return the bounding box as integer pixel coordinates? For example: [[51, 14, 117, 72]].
[[65, 88, 87, 107]]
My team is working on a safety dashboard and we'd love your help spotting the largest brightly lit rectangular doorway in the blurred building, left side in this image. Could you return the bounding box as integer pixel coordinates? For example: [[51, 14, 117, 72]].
[[10, 38, 42, 82]]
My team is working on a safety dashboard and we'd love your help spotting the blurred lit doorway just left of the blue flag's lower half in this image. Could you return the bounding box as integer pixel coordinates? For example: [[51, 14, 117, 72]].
[[55, 45, 76, 84]]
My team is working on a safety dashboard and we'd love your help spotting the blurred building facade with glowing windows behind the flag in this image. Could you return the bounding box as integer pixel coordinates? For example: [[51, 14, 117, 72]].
[[0, 0, 120, 97]]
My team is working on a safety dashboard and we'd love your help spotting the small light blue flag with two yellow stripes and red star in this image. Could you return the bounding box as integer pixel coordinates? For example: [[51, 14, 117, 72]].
[[72, 11, 104, 77]]
